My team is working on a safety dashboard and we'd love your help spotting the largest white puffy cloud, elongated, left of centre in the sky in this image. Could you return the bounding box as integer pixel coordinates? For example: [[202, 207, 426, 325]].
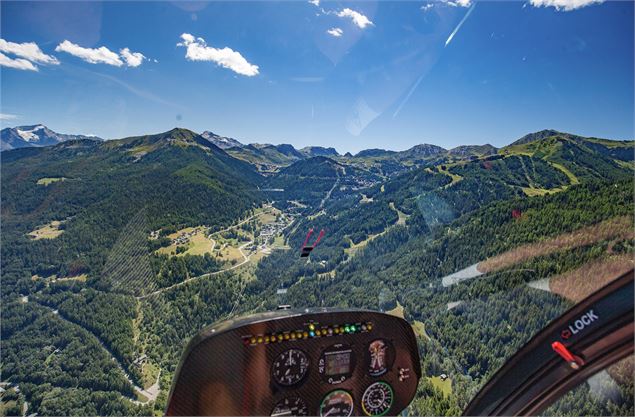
[[176, 33, 259, 77]]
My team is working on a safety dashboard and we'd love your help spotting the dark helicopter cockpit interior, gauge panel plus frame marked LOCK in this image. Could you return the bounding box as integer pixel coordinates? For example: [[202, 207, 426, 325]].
[[166, 271, 634, 417]]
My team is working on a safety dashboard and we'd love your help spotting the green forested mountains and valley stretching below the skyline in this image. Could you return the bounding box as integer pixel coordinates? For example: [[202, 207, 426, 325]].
[[0, 127, 635, 415]]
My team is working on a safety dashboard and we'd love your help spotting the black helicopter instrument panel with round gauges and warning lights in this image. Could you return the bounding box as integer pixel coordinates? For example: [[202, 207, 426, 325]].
[[166, 309, 421, 417]]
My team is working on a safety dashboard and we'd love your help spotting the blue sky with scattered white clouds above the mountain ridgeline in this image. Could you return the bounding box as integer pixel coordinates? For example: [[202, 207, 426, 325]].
[[0, 0, 635, 152]]
